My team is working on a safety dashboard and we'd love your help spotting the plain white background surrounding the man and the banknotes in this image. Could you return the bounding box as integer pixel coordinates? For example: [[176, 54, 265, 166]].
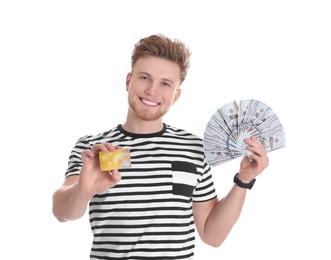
[[0, 0, 331, 260]]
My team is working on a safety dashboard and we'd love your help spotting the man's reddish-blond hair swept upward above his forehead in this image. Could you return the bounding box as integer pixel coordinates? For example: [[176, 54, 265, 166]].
[[131, 34, 191, 83]]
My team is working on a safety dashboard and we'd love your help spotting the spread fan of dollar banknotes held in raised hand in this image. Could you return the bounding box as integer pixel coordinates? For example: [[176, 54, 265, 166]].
[[203, 99, 285, 166]]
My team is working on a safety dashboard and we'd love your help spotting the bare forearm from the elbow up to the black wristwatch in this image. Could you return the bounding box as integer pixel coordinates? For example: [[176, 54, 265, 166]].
[[204, 185, 247, 247]]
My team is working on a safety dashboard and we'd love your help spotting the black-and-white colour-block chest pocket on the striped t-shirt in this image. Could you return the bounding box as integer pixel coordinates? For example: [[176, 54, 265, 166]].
[[171, 161, 198, 197]]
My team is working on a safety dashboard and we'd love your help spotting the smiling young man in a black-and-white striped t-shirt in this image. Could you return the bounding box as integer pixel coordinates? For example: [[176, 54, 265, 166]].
[[53, 35, 268, 260]]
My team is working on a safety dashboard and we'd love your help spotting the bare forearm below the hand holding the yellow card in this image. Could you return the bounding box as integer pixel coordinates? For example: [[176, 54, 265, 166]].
[[53, 183, 90, 222]]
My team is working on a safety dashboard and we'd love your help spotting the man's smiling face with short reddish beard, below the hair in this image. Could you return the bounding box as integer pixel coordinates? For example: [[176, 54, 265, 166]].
[[126, 56, 181, 121]]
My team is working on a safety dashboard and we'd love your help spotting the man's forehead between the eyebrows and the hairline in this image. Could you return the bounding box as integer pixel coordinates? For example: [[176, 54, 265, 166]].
[[133, 56, 180, 82]]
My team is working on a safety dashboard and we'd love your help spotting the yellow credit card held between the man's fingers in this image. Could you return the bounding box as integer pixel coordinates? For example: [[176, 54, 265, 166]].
[[99, 148, 131, 171]]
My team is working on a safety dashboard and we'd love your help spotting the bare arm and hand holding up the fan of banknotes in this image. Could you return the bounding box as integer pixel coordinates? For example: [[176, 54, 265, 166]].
[[193, 137, 269, 247]]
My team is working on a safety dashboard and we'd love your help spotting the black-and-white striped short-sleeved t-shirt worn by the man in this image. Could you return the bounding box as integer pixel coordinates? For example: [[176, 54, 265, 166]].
[[66, 124, 216, 260]]
